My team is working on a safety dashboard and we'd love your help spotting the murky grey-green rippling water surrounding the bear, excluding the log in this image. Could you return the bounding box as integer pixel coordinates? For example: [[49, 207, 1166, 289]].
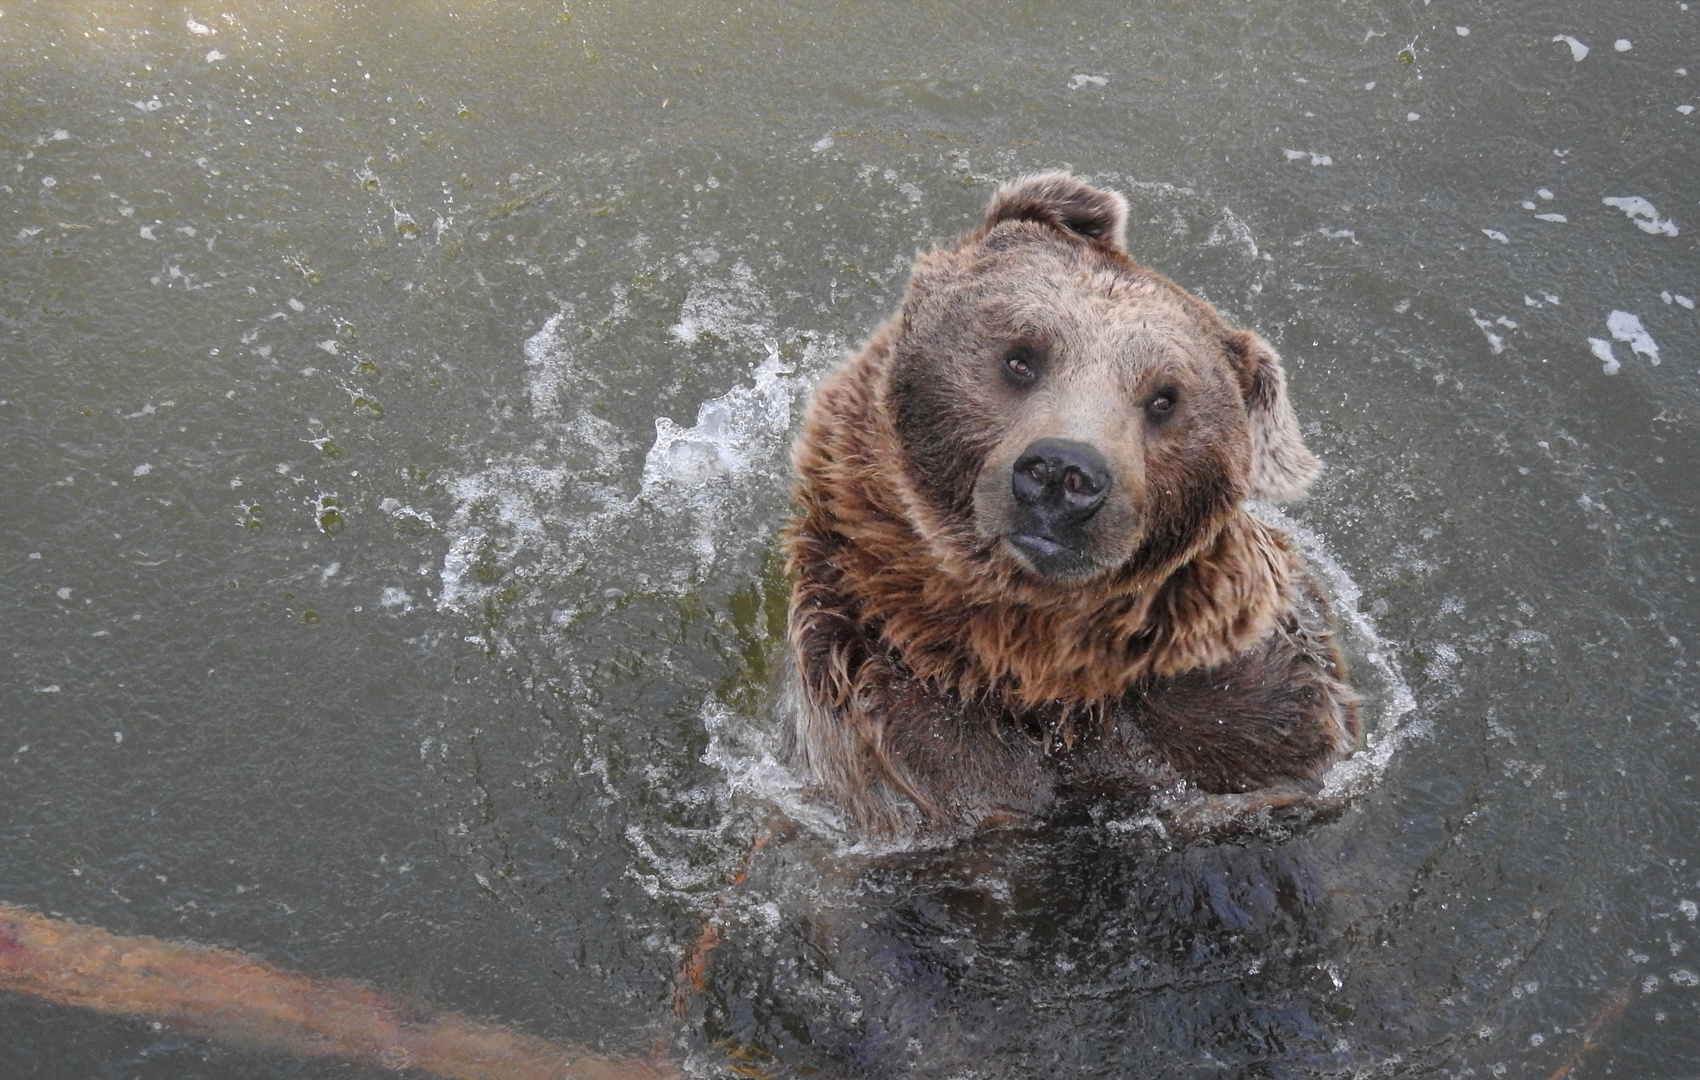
[[0, 0, 1700, 1078]]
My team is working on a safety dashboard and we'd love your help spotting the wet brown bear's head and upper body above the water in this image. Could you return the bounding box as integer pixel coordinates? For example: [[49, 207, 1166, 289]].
[[780, 172, 1362, 838]]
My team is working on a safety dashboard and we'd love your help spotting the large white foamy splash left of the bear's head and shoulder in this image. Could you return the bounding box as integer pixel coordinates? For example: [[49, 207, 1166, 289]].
[[437, 260, 842, 629]]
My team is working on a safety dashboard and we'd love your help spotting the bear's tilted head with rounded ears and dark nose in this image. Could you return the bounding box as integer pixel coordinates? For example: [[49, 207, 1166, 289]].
[[879, 173, 1318, 594]]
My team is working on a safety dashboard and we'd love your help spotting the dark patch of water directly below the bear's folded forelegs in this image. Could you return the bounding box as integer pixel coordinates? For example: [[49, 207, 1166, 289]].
[[695, 799, 1421, 1077]]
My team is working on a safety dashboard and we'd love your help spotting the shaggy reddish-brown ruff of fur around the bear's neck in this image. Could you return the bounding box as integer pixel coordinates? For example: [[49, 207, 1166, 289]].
[[785, 327, 1290, 717]]
